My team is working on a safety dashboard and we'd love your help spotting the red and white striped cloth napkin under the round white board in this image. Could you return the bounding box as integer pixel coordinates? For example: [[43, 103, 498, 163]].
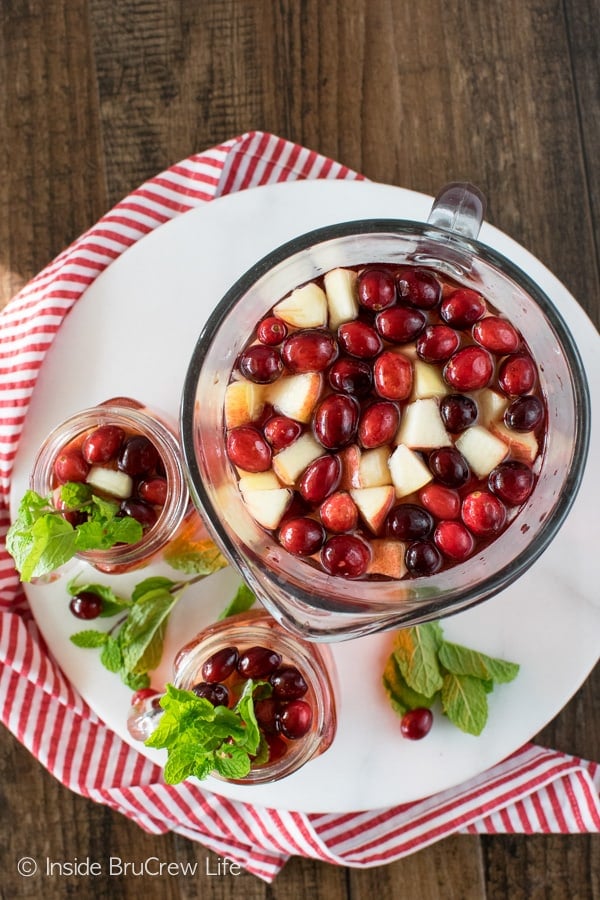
[[0, 132, 600, 881]]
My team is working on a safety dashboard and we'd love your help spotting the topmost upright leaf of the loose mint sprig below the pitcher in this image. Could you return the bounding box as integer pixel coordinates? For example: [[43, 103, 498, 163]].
[[394, 622, 442, 697]]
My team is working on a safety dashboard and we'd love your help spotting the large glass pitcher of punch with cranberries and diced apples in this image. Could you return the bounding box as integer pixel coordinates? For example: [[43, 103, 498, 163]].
[[182, 185, 589, 640]]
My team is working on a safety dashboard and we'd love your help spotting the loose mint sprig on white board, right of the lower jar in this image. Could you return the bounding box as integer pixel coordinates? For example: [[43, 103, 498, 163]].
[[383, 622, 519, 735]]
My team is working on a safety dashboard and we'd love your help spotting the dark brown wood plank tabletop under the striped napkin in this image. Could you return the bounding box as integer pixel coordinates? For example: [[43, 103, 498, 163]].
[[0, 0, 600, 900]]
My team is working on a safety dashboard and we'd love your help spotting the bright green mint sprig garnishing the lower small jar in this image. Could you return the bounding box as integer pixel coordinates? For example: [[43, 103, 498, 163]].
[[145, 679, 261, 784]]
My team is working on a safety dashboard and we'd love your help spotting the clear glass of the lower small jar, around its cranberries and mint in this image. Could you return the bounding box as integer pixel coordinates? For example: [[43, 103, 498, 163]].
[[127, 609, 337, 784]]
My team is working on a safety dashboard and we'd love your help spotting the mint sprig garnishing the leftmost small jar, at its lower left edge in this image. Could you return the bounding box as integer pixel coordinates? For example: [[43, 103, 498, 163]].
[[6, 482, 143, 581]]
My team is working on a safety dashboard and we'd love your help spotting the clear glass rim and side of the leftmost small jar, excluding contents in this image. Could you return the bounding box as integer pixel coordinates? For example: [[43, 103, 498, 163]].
[[30, 397, 190, 574]]
